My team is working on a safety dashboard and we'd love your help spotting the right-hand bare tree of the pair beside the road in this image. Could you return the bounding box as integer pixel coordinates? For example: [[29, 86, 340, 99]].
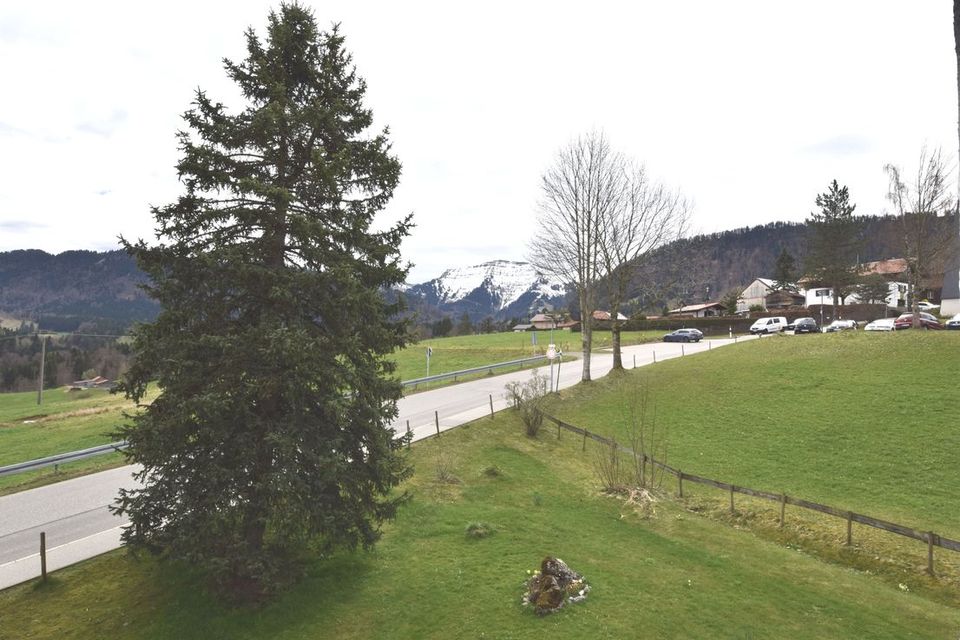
[[598, 159, 690, 369]]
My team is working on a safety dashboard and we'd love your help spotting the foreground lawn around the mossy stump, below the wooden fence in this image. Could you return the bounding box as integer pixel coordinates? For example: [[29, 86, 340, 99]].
[[0, 404, 960, 639]]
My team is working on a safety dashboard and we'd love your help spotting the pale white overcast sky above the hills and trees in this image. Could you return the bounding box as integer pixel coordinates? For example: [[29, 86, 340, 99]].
[[0, 0, 957, 282]]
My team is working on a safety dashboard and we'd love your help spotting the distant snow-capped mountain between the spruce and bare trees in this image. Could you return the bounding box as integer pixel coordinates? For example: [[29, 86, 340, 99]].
[[406, 260, 566, 320]]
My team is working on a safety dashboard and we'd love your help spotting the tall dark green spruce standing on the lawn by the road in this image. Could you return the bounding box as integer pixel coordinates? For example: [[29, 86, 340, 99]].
[[115, 4, 411, 600]]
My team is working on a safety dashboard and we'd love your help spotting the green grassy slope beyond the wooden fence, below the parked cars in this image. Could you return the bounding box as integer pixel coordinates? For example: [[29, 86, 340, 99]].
[[557, 331, 960, 539]]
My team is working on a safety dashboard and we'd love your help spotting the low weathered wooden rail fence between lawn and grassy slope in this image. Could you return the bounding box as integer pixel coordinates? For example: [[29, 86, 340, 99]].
[[543, 413, 960, 575]]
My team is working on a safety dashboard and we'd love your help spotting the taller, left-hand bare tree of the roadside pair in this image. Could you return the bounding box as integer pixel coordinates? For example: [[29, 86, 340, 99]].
[[529, 132, 627, 382]]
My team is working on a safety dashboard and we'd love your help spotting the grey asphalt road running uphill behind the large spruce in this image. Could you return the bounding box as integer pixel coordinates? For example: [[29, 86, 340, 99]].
[[0, 337, 752, 589]]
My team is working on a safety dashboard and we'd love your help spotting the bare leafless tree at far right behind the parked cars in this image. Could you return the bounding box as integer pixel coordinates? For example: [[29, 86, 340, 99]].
[[884, 148, 954, 328]]
